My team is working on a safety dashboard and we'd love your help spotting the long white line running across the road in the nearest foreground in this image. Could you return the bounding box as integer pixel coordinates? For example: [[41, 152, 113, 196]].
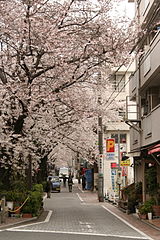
[[7, 229, 148, 237]]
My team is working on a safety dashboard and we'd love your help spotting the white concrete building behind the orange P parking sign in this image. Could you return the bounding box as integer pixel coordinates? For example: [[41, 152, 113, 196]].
[[103, 64, 135, 201]]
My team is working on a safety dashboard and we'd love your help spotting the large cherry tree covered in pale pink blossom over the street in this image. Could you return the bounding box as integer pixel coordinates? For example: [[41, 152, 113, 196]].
[[0, 0, 135, 182]]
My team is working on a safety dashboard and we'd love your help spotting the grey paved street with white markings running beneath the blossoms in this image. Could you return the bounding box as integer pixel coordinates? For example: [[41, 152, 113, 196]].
[[0, 186, 155, 240]]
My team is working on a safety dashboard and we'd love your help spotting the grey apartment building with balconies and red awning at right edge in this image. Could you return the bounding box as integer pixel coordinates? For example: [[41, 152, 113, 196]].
[[126, 0, 160, 201]]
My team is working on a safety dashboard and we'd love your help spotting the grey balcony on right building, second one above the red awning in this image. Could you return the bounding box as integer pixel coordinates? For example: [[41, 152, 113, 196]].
[[140, 31, 160, 88]]
